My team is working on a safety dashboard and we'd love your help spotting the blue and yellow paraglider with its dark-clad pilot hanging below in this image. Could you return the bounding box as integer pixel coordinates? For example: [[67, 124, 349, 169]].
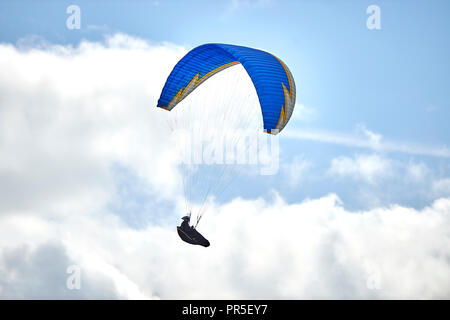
[[157, 43, 296, 246]]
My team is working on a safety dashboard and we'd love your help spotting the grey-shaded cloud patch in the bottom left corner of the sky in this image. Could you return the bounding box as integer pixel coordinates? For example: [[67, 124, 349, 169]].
[[0, 243, 120, 299]]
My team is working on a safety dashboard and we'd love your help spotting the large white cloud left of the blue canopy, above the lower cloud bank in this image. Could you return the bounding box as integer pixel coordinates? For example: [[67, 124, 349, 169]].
[[0, 34, 185, 216]]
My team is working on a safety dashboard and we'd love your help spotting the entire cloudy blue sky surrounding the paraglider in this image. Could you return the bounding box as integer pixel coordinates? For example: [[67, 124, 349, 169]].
[[0, 0, 450, 299]]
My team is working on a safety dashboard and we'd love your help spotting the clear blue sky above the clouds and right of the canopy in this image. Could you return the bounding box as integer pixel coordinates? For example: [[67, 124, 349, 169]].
[[0, 1, 450, 212]]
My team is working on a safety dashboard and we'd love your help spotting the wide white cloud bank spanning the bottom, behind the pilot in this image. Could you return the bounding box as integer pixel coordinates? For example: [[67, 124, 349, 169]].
[[0, 195, 450, 299]]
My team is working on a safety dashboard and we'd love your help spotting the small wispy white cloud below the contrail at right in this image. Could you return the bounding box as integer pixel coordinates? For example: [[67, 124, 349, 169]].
[[328, 154, 393, 183]]
